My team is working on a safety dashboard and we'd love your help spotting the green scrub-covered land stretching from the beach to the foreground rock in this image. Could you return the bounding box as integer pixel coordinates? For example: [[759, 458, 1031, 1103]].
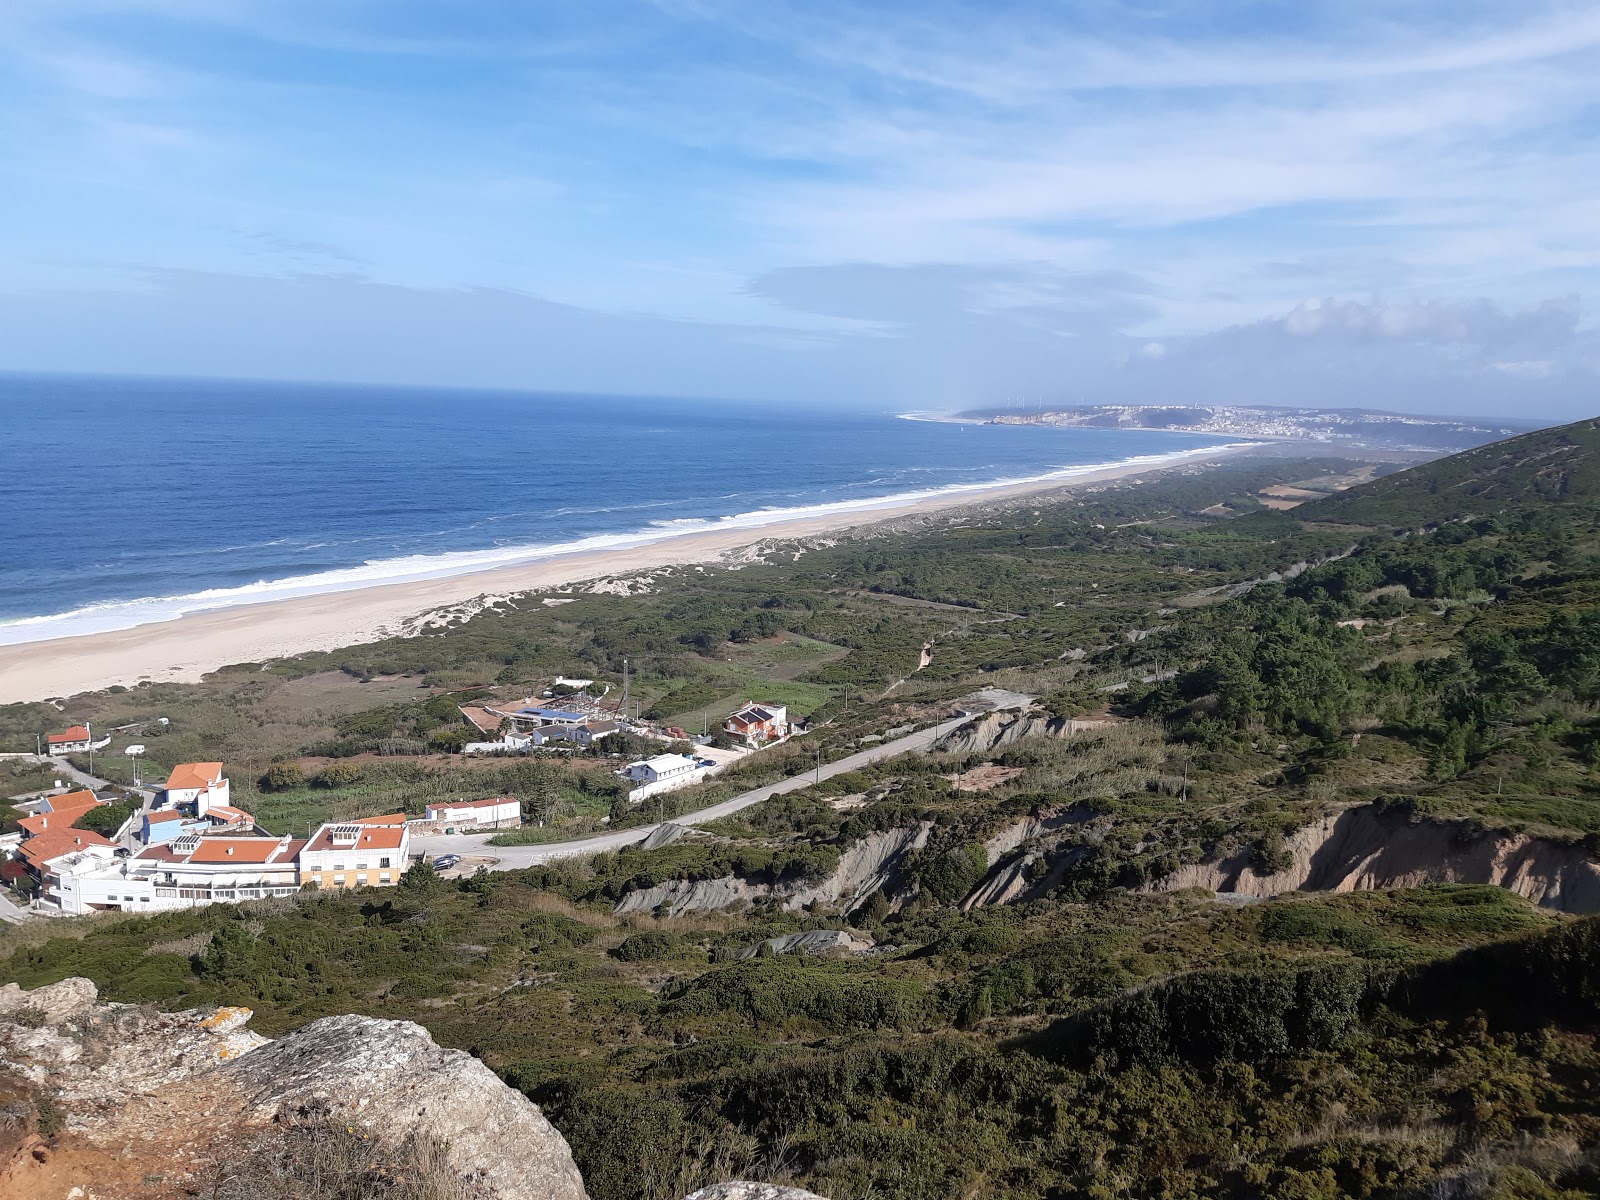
[[0, 441, 1600, 1200]]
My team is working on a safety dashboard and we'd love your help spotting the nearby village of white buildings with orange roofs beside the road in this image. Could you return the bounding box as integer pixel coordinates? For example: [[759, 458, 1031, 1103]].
[[0, 677, 795, 920]]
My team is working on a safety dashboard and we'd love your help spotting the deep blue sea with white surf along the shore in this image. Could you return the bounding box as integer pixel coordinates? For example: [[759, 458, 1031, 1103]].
[[0, 376, 1222, 643]]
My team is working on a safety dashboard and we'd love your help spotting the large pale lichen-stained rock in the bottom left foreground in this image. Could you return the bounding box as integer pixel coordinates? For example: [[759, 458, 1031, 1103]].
[[0, 979, 584, 1200]]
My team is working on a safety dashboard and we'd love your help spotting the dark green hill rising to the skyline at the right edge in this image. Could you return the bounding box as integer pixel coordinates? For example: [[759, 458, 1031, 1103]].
[[1294, 418, 1600, 525]]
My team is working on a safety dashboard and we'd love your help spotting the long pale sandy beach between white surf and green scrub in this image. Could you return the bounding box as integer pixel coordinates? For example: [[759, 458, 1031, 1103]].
[[0, 446, 1250, 704]]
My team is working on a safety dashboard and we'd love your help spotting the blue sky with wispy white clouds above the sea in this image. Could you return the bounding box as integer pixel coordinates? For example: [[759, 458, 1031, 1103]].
[[0, 0, 1600, 419]]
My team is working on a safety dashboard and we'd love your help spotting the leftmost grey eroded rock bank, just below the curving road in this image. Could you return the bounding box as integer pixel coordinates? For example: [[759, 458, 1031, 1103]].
[[613, 824, 930, 917]]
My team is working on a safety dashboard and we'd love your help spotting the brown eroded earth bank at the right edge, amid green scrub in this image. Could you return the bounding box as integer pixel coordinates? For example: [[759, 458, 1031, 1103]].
[[1150, 805, 1600, 912]]
